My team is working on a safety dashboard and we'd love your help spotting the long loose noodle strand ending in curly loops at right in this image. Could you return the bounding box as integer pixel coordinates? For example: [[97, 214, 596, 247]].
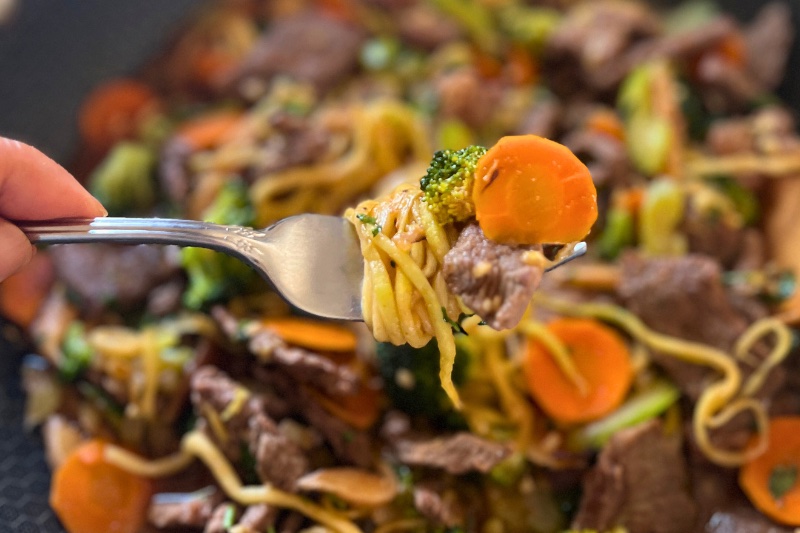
[[534, 294, 790, 466]]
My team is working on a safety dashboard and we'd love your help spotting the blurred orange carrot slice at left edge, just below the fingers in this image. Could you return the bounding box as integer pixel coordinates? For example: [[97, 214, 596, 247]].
[[0, 252, 55, 328]]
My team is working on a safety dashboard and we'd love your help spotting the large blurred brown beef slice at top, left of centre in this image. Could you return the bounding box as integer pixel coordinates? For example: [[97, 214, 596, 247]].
[[226, 13, 363, 97]]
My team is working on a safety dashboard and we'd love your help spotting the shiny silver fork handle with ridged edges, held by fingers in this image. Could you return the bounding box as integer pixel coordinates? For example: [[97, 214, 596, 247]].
[[15, 217, 241, 252]]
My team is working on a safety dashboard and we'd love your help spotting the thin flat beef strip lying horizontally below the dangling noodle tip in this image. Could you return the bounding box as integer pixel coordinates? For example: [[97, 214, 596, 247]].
[[394, 432, 511, 474]]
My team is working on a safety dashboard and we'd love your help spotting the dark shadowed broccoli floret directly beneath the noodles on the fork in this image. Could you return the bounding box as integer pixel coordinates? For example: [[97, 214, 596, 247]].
[[376, 339, 470, 427]]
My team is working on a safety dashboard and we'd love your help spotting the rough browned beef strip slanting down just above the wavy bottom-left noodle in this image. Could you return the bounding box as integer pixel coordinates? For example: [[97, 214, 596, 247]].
[[191, 366, 308, 490]]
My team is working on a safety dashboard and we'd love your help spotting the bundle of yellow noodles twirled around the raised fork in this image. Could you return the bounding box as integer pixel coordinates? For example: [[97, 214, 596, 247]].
[[345, 184, 461, 408]]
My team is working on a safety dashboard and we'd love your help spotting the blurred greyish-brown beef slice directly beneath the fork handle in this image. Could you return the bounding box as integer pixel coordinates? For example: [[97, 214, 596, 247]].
[[51, 244, 178, 312]]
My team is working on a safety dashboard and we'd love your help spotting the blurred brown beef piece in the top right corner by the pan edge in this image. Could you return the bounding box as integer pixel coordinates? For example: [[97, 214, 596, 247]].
[[744, 2, 794, 90]]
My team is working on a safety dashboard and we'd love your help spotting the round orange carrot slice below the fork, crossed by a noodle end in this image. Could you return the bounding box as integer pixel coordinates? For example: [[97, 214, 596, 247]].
[[523, 318, 633, 424]]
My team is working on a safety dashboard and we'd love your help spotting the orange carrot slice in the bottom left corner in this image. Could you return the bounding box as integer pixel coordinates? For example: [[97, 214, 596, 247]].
[[50, 440, 151, 533]]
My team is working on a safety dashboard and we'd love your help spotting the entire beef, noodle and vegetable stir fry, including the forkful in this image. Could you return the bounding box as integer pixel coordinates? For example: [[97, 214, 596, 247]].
[[0, 0, 800, 533]]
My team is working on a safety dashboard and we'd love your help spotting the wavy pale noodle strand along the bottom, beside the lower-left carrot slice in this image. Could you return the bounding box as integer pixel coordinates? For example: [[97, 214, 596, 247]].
[[104, 431, 361, 533]]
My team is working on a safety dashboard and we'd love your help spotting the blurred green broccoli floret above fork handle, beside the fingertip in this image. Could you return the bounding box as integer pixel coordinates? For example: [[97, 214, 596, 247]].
[[89, 142, 156, 215]]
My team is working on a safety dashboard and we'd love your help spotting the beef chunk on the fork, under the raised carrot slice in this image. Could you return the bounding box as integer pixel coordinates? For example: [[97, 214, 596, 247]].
[[442, 220, 543, 329]]
